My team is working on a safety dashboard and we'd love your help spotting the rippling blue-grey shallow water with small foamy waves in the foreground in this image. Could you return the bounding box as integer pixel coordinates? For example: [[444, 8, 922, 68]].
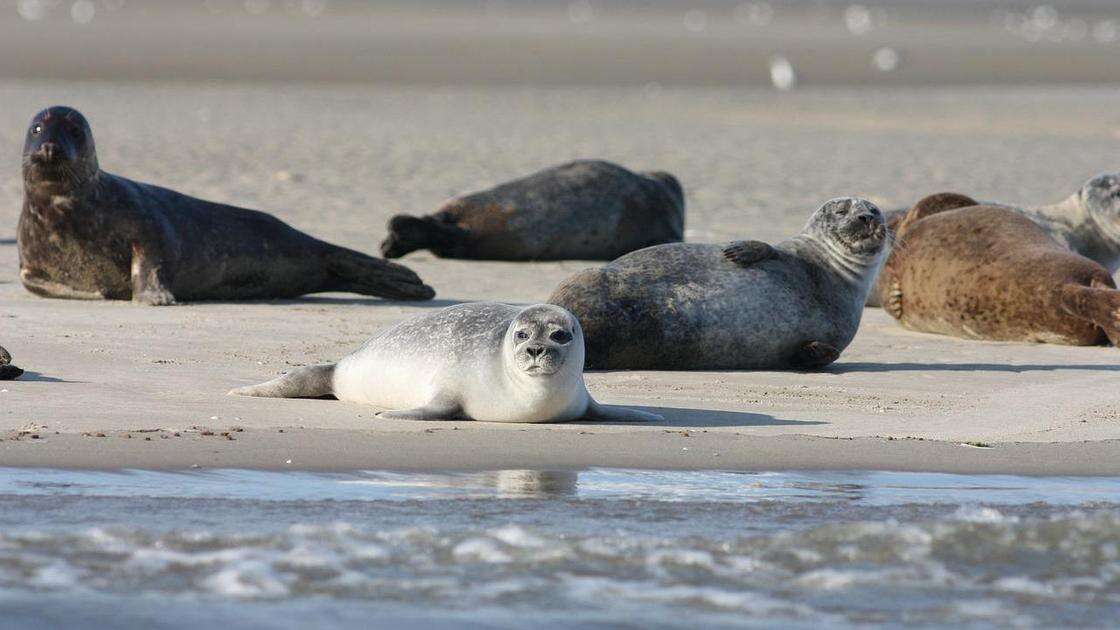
[[0, 469, 1120, 628]]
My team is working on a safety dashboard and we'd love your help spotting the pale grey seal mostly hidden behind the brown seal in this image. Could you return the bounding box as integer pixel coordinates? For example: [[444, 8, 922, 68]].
[[867, 173, 1120, 306]]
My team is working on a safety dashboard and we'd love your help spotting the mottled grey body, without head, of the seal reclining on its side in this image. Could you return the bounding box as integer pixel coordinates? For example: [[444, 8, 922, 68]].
[[549, 243, 859, 370]]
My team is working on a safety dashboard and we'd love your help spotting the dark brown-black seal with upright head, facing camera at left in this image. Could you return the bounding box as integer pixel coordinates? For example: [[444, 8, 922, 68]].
[[17, 106, 435, 305]]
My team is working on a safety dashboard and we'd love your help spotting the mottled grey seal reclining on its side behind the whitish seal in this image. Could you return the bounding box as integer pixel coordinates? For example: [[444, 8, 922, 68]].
[[549, 197, 886, 370]]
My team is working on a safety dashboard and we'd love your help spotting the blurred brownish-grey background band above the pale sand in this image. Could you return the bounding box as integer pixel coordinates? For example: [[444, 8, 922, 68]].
[[0, 0, 1120, 90]]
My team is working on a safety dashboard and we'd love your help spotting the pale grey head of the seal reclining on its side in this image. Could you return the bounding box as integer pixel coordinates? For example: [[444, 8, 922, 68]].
[[805, 197, 887, 259]]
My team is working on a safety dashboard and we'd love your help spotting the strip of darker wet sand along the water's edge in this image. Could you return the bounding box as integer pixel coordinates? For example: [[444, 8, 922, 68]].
[[0, 423, 1120, 476]]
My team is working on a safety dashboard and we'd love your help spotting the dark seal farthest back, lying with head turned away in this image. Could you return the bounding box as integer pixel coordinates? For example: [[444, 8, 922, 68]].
[[381, 160, 684, 260]]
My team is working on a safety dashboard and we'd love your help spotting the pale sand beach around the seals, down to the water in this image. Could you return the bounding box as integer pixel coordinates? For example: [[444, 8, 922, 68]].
[[0, 81, 1120, 474]]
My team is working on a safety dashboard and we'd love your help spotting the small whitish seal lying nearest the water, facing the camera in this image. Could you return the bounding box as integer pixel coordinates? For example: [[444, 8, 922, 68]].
[[230, 303, 661, 423]]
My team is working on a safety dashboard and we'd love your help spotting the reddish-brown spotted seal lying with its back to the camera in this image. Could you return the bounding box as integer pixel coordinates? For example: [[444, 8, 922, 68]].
[[880, 193, 1120, 345]]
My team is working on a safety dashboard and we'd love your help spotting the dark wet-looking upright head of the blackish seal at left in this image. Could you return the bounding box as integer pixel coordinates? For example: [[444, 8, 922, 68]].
[[24, 105, 97, 194]]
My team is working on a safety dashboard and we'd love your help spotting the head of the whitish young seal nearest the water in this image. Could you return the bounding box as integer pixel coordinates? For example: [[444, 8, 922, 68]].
[[506, 304, 584, 377]]
